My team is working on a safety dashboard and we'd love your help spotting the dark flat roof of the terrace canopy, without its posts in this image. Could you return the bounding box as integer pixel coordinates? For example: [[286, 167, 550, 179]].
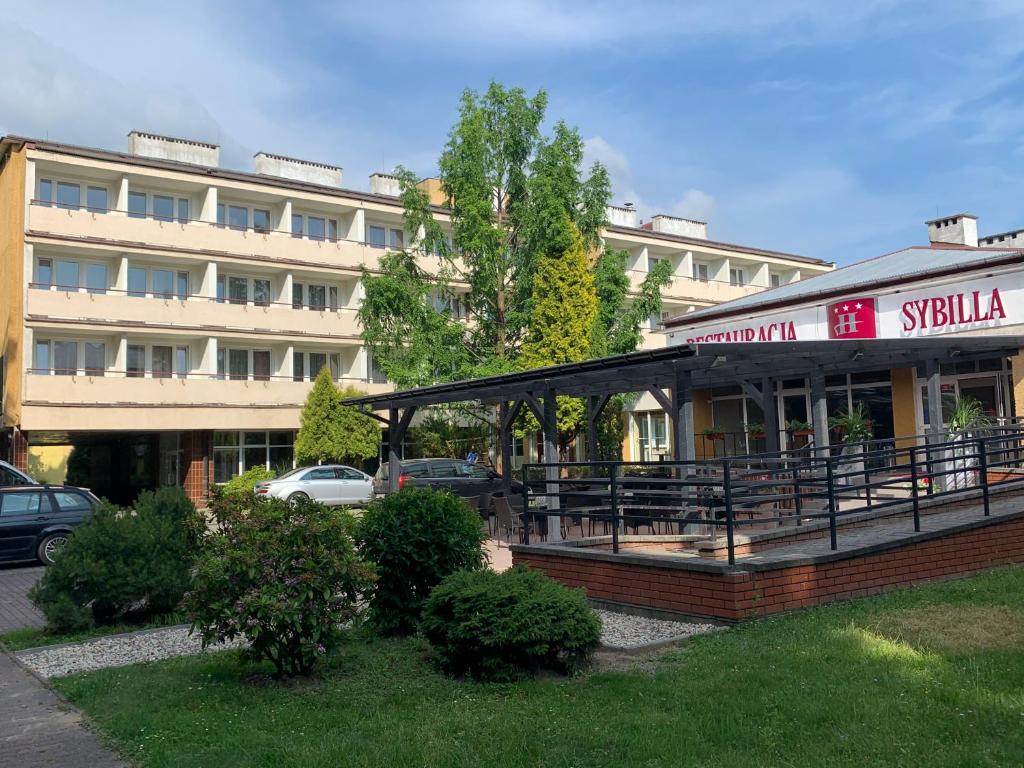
[[345, 336, 1024, 411]]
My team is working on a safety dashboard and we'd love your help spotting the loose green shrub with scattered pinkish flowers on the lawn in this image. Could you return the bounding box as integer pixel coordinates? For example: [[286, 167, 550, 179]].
[[184, 495, 373, 677]]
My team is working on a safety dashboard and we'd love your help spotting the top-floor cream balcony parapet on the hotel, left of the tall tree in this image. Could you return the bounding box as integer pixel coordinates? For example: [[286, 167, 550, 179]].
[[26, 203, 384, 268]]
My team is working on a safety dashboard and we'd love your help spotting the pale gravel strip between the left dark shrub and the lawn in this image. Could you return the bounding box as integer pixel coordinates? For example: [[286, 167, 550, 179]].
[[15, 627, 245, 677]]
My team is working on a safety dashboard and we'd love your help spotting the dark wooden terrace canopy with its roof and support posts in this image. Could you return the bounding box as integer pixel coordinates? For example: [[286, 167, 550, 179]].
[[346, 335, 1024, 527]]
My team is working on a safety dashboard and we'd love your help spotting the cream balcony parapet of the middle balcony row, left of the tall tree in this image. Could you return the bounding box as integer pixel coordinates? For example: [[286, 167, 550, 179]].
[[26, 286, 359, 341]]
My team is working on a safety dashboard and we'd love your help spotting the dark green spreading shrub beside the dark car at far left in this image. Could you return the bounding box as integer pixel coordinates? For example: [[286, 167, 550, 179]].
[[30, 487, 205, 632]]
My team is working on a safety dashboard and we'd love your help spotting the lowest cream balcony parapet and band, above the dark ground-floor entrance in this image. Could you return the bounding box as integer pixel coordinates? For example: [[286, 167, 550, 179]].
[[22, 372, 393, 431]]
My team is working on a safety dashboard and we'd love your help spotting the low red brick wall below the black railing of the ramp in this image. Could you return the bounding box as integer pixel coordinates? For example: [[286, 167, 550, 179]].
[[512, 517, 1024, 620]]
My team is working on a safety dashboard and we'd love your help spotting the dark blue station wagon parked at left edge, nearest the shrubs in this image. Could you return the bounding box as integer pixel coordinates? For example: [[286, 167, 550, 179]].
[[0, 483, 99, 565]]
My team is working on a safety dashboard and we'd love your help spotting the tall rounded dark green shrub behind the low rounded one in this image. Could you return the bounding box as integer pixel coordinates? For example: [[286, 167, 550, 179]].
[[356, 487, 486, 635]]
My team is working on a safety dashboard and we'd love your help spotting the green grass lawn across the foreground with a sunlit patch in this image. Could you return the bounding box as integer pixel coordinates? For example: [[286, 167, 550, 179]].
[[55, 568, 1024, 768]]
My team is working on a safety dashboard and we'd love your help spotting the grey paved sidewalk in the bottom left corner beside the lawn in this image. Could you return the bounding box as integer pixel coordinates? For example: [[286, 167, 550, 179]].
[[0, 653, 126, 768]]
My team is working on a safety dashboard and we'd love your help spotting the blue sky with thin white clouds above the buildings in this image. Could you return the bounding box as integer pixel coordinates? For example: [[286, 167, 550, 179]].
[[0, 0, 1024, 263]]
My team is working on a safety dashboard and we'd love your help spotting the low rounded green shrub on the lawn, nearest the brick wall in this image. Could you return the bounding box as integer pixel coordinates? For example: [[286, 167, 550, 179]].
[[420, 566, 601, 682]]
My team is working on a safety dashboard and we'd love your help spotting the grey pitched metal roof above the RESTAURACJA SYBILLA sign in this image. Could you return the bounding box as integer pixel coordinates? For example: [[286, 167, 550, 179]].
[[665, 246, 1024, 328]]
